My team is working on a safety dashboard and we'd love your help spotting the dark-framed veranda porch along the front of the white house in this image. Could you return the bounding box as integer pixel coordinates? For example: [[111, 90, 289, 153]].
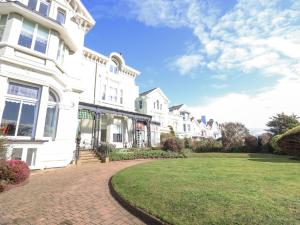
[[78, 102, 151, 150]]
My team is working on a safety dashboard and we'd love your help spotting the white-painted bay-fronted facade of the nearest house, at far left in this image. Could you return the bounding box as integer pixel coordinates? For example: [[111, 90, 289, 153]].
[[0, 0, 95, 169]]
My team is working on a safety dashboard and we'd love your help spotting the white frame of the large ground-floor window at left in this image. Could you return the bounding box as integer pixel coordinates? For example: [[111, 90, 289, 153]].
[[1, 81, 41, 139]]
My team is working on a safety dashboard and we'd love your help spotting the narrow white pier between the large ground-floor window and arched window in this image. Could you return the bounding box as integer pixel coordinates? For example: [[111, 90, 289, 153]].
[[35, 86, 49, 139]]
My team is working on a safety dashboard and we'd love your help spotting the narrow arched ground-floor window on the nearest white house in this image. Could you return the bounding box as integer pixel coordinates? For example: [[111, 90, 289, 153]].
[[44, 90, 59, 140]]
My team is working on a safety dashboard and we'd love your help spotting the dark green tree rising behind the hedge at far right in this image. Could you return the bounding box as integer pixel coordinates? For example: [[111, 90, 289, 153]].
[[266, 113, 300, 135]]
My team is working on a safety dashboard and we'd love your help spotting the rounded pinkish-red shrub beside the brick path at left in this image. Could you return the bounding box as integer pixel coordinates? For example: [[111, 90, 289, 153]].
[[6, 160, 30, 184]]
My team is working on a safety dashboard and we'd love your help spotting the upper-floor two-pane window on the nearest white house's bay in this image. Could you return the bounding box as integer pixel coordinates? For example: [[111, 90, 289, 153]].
[[18, 19, 49, 53]]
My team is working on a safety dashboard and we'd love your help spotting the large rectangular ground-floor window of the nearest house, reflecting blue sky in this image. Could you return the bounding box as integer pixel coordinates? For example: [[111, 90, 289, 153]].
[[1, 82, 39, 137]]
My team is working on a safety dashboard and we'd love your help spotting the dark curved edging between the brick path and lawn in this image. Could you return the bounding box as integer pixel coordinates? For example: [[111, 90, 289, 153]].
[[108, 177, 169, 225]]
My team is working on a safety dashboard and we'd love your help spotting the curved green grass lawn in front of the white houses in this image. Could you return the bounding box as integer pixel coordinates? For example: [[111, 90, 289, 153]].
[[112, 153, 300, 225]]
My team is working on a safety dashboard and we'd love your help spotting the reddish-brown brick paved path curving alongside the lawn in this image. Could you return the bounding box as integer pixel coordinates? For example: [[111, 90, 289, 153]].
[[0, 160, 150, 225]]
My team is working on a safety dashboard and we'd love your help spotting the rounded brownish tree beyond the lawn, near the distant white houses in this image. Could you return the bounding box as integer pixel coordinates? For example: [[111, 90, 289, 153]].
[[221, 122, 249, 148]]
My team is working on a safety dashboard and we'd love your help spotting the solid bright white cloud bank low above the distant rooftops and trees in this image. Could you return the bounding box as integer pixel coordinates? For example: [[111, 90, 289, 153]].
[[190, 78, 300, 129]]
